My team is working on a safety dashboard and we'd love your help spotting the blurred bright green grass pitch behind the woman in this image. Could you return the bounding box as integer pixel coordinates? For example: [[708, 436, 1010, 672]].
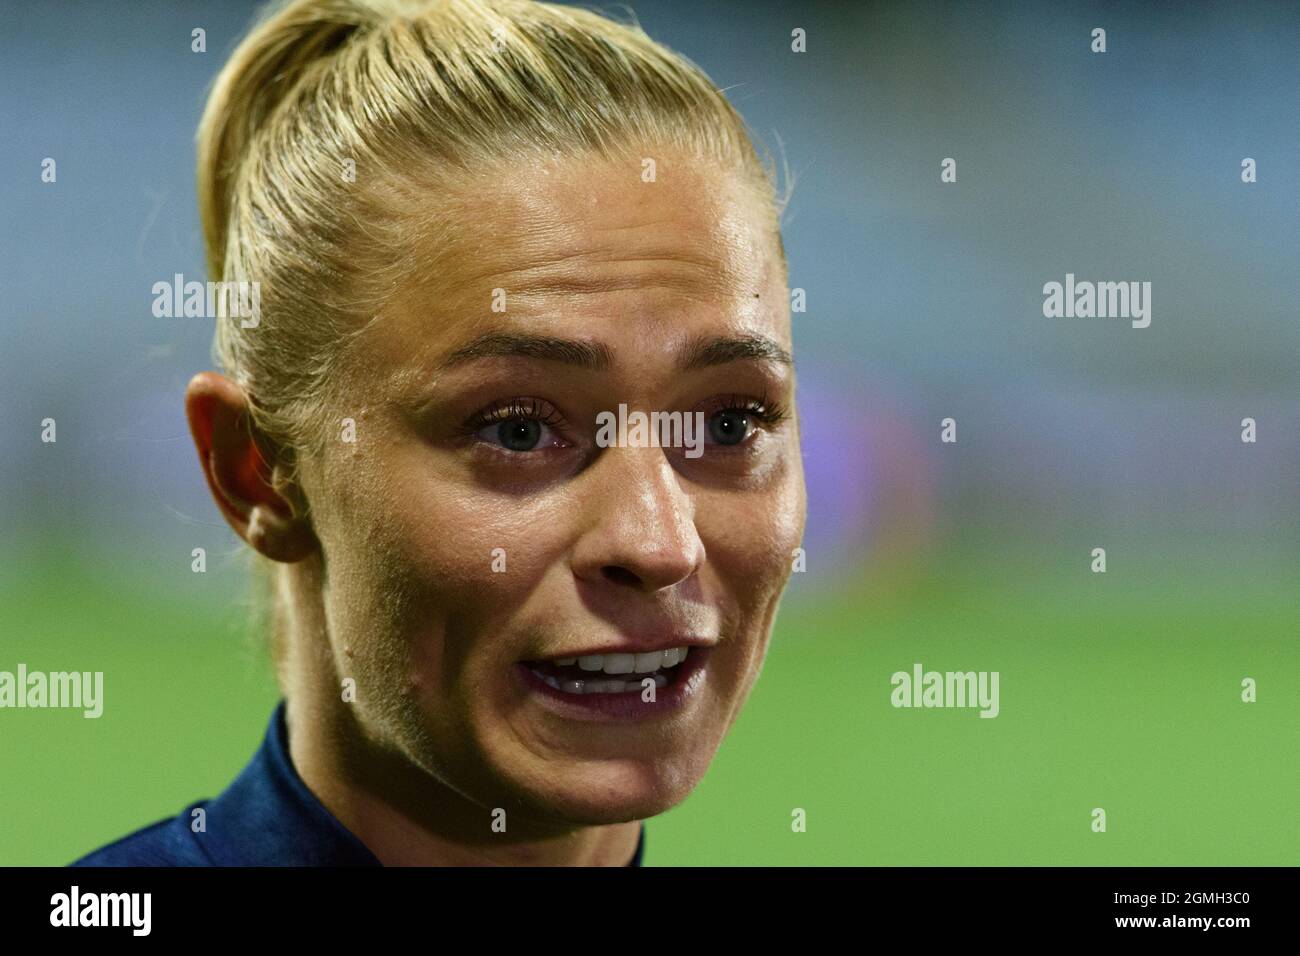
[[0, 541, 1300, 865]]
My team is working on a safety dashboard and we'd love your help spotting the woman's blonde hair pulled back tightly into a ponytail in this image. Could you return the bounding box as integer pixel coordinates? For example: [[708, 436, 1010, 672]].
[[198, 0, 788, 671]]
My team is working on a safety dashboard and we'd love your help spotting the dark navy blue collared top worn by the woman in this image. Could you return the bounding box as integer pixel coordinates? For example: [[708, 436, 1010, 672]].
[[73, 701, 645, 866]]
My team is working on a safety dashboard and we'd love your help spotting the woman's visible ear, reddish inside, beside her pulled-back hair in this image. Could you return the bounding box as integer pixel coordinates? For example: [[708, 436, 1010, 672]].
[[185, 372, 320, 563]]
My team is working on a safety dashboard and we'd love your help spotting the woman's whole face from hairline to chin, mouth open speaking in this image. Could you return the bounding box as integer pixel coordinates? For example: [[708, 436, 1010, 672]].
[[303, 149, 805, 825]]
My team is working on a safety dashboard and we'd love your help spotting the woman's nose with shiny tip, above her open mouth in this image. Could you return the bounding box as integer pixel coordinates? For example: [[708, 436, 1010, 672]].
[[572, 446, 705, 594]]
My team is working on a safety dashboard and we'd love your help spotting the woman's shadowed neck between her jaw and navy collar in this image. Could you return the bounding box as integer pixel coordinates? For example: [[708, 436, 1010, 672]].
[[281, 562, 641, 866]]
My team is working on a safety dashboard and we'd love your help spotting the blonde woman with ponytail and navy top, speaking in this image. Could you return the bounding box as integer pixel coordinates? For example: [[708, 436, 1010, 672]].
[[78, 0, 805, 865]]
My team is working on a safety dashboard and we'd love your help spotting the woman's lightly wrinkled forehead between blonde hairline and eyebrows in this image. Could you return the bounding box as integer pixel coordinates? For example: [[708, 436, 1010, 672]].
[[356, 147, 789, 378]]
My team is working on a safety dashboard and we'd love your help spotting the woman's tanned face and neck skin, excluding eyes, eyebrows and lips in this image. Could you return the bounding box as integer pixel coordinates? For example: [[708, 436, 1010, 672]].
[[274, 155, 805, 862]]
